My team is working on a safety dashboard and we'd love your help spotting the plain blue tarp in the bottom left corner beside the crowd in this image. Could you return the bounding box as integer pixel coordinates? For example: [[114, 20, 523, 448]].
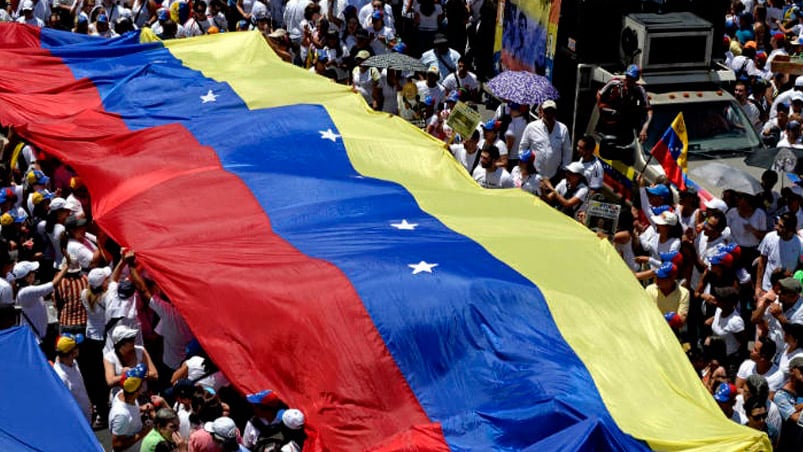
[[0, 327, 103, 452]]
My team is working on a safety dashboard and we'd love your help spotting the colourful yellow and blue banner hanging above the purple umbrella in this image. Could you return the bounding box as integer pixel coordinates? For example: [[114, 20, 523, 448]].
[[495, 0, 560, 80]]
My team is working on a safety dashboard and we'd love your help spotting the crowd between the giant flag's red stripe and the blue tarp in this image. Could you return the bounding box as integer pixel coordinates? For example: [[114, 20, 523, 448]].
[[0, 133, 306, 444]]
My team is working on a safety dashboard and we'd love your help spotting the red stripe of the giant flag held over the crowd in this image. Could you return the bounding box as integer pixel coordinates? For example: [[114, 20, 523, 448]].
[[0, 27, 447, 450]]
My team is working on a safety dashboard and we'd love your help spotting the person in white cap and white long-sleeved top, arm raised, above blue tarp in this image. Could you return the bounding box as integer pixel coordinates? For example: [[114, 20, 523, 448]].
[[10, 261, 67, 343]]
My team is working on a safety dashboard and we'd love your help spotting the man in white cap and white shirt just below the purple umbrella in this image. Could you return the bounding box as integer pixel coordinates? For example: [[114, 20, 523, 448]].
[[519, 100, 572, 182]]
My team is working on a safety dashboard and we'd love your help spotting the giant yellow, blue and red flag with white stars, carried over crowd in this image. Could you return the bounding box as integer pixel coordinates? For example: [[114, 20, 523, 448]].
[[0, 25, 769, 451]]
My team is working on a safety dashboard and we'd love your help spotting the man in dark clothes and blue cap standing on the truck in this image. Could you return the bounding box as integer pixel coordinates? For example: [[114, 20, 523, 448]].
[[597, 64, 652, 144]]
